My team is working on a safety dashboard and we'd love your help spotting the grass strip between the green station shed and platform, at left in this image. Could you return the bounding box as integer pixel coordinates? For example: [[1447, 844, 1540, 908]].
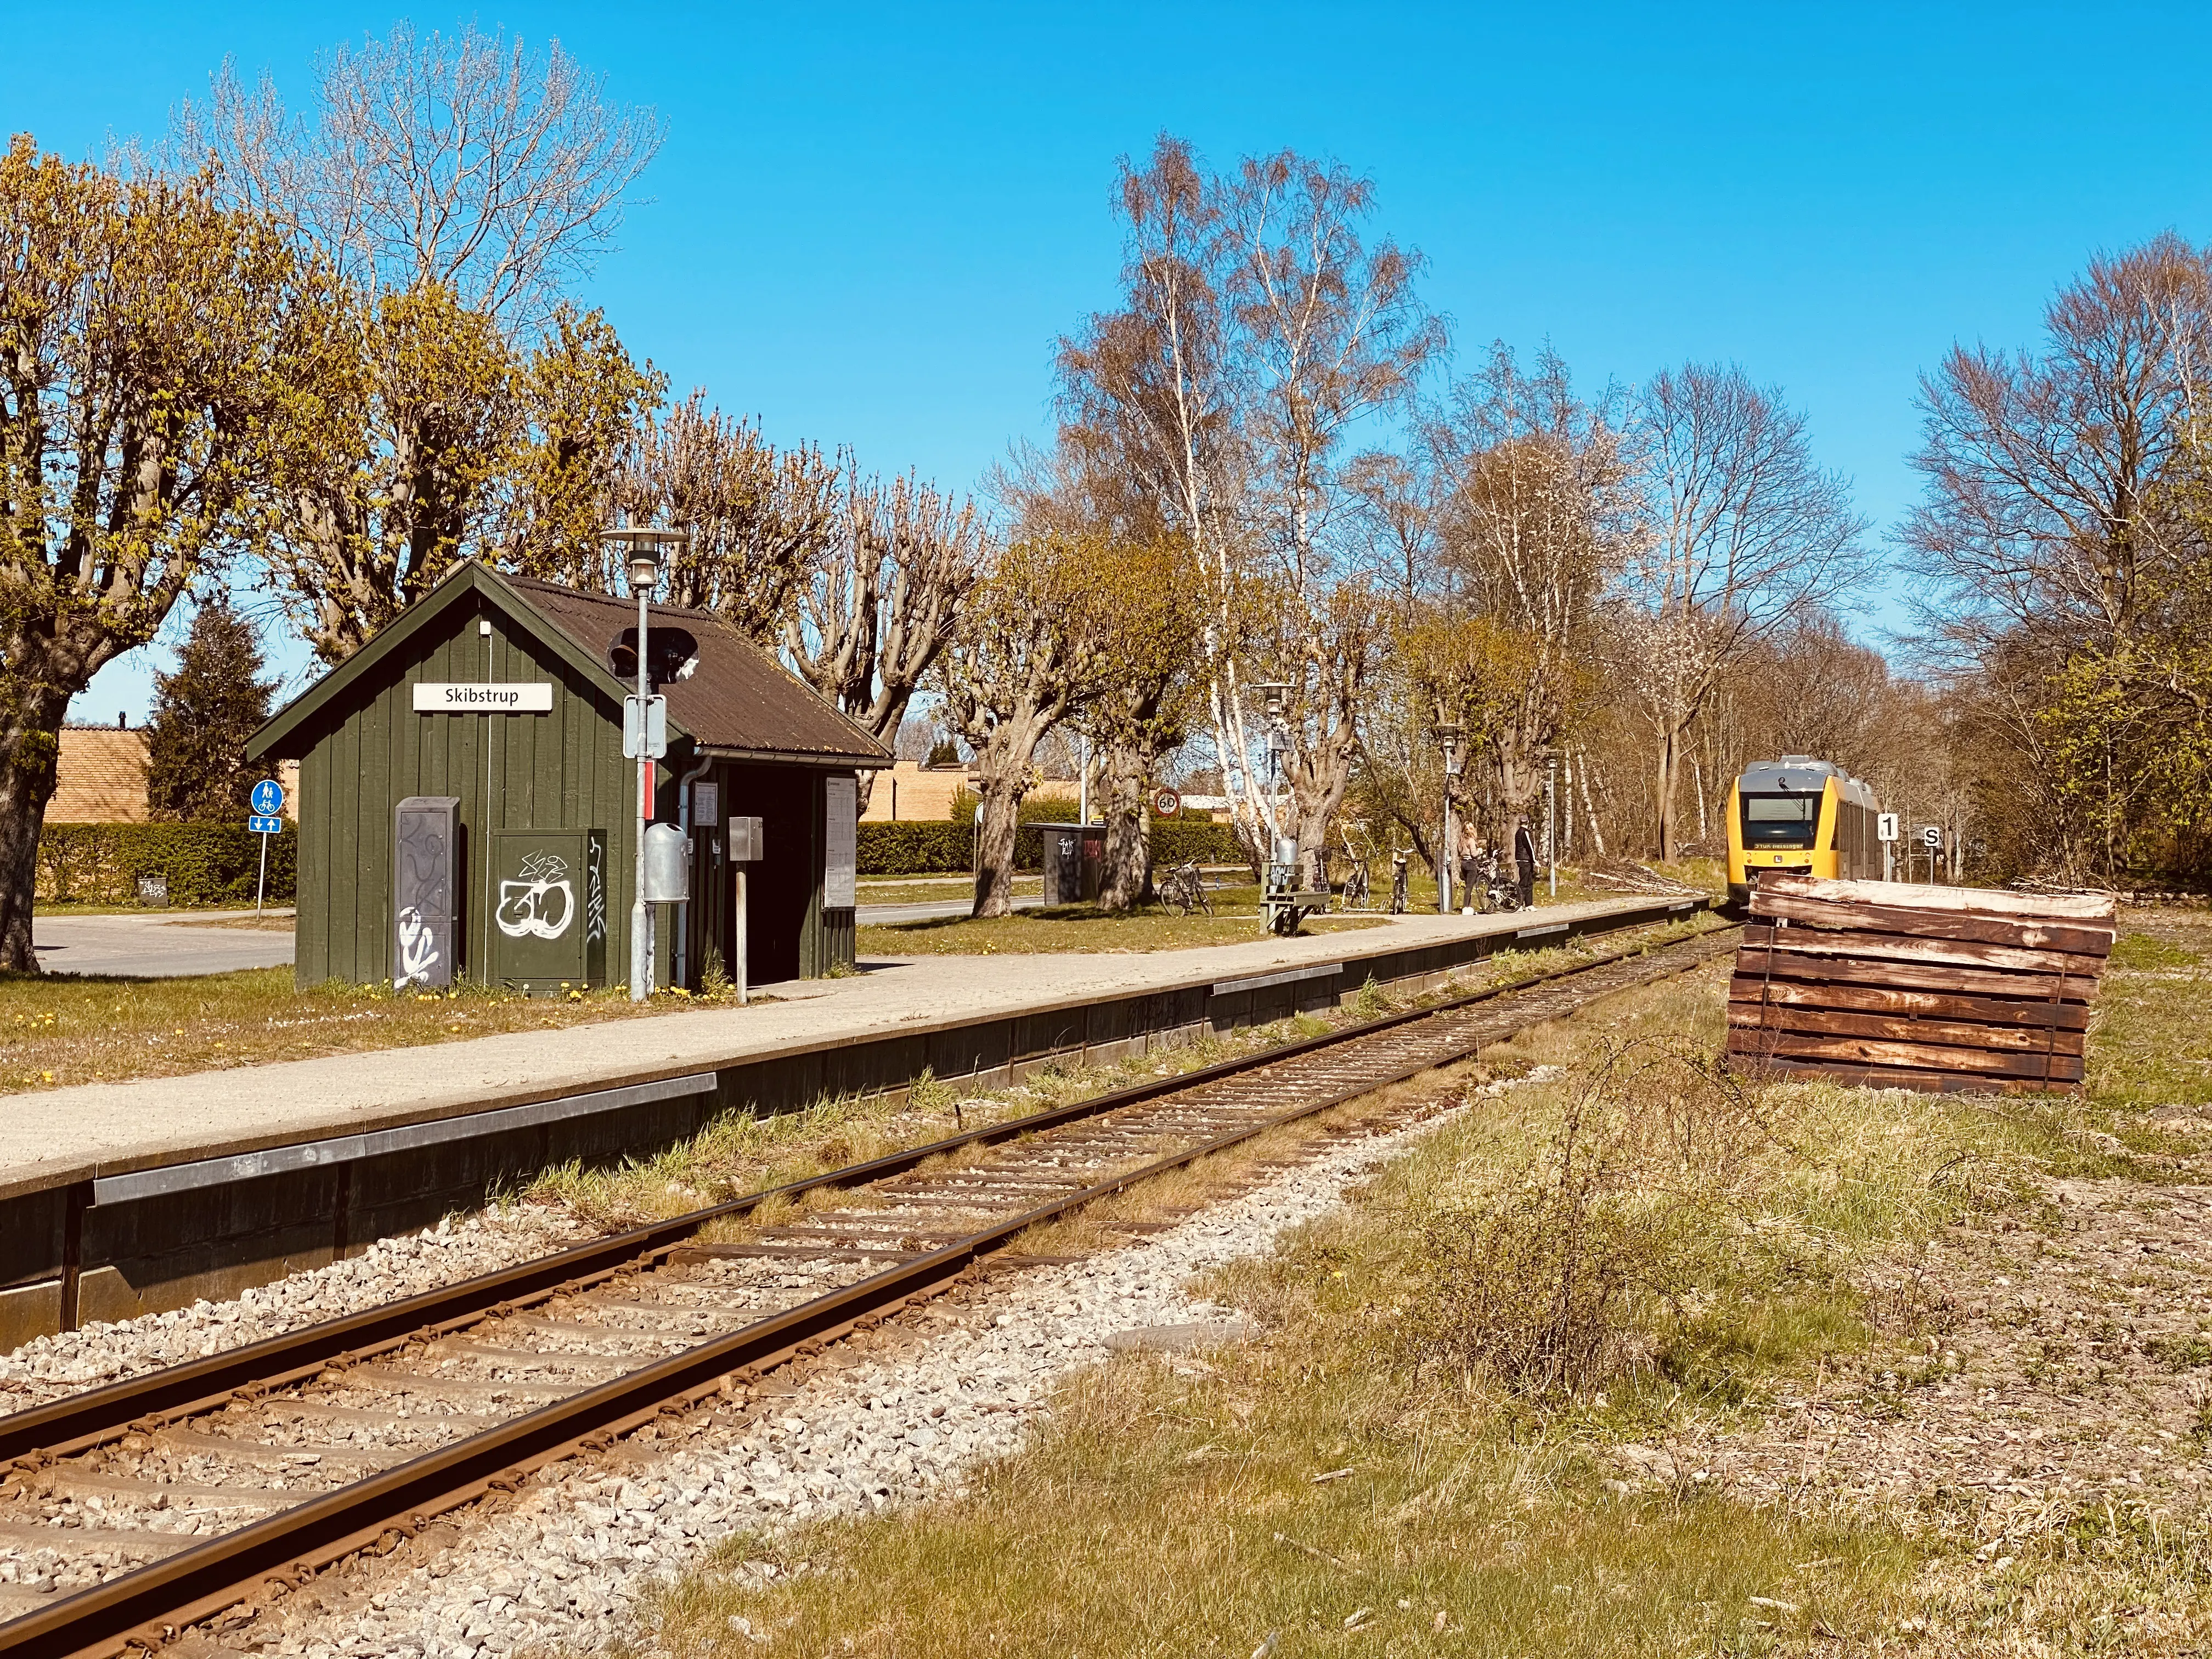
[[0, 967, 697, 1095]]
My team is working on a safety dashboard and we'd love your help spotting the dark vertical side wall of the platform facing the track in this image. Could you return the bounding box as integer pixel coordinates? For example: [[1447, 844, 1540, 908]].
[[0, 898, 1708, 1352]]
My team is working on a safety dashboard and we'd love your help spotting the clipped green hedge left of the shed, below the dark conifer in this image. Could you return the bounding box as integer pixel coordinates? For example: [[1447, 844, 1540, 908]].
[[38, 823, 298, 905]]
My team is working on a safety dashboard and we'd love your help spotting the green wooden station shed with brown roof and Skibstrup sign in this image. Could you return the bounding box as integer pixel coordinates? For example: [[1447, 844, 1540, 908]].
[[248, 562, 891, 993]]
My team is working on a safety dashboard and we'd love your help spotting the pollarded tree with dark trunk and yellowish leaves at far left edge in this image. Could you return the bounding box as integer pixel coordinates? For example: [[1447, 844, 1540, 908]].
[[0, 137, 318, 971]]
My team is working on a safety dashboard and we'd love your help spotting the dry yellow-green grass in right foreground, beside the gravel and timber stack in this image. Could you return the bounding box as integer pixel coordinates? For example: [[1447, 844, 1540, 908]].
[[657, 929, 2212, 1659]]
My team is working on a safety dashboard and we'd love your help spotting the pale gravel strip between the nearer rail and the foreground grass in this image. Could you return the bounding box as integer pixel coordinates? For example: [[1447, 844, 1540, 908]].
[[248, 1084, 1502, 1659]]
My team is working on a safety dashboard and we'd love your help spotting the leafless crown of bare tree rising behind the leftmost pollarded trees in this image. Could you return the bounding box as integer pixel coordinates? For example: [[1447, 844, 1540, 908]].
[[172, 22, 662, 332]]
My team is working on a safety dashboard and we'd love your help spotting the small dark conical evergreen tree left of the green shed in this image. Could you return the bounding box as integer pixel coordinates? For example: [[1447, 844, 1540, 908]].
[[146, 595, 276, 823]]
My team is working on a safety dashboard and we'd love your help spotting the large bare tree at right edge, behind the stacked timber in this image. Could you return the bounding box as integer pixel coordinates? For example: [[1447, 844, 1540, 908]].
[[1905, 234, 2212, 881]]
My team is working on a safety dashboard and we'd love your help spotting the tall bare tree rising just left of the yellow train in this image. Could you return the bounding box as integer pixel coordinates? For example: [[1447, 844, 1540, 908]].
[[1626, 363, 1867, 858]]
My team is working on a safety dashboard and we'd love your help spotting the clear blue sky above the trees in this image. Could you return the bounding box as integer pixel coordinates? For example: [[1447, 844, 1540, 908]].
[[0, 4, 2212, 719]]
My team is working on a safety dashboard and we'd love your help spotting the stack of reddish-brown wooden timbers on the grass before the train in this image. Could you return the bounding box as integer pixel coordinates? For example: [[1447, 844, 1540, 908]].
[[1728, 876, 2117, 1093]]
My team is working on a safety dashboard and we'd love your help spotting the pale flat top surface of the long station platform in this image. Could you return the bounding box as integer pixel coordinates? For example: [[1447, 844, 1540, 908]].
[[0, 896, 1699, 1197]]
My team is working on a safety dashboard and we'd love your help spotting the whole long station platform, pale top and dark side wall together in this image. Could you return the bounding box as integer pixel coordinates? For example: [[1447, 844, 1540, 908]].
[[0, 896, 1706, 1347]]
